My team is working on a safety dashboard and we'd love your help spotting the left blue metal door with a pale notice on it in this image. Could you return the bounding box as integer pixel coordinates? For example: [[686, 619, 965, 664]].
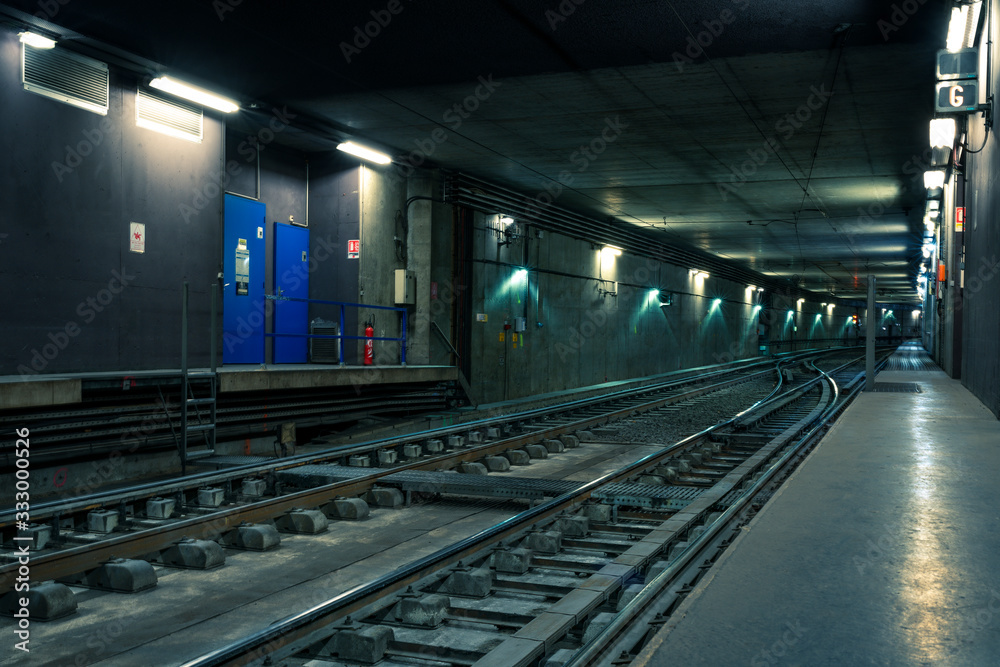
[[222, 194, 267, 364]]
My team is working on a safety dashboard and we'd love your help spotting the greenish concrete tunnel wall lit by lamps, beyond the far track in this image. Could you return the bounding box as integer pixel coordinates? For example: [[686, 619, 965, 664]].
[[470, 214, 757, 402]]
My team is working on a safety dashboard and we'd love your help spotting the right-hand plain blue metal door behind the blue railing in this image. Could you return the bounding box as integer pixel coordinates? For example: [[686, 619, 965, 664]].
[[274, 223, 309, 364]]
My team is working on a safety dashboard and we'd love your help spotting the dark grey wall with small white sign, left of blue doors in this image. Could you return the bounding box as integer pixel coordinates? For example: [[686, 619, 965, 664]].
[[0, 28, 223, 375]]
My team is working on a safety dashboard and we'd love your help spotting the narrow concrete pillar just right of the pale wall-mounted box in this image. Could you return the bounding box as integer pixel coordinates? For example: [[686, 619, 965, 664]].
[[406, 171, 434, 365]]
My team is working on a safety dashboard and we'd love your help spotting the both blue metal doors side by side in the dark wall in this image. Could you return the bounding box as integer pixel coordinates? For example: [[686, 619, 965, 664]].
[[222, 194, 309, 364]]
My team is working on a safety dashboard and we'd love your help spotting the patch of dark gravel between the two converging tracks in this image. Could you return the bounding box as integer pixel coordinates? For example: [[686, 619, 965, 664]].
[[595, 378, 774, 444]]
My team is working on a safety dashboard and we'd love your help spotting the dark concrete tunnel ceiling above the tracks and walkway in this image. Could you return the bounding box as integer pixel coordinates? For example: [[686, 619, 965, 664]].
[[7, 0, 948, 301]]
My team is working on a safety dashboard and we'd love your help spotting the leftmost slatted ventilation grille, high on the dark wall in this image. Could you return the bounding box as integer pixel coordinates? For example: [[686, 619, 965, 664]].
[[21, 44, 108, 116]]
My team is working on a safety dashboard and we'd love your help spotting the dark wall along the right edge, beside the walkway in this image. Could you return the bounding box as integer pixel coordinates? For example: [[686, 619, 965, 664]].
[[956, 0, 1000, 417]]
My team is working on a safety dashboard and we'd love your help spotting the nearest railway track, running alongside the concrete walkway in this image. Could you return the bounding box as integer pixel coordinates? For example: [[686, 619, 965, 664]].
[[170, 352, 884, 667]]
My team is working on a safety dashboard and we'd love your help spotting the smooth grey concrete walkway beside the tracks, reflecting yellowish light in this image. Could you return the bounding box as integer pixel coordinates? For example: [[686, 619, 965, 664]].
[[632, 348, 1000, 667]]
